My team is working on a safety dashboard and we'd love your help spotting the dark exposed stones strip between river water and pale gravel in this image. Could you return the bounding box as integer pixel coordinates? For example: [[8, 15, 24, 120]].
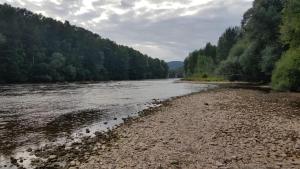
[[32, 88, 218, 169]]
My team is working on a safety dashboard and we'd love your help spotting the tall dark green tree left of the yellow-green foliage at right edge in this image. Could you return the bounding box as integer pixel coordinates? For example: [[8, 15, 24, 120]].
[[239, 0, 283, 82]]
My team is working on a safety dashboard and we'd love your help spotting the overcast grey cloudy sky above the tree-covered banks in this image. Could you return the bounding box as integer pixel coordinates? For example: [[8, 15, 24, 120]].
[[0, 0, 253, 61]]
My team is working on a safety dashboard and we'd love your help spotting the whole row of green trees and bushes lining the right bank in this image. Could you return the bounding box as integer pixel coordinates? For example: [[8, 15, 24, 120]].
[[184, 0, 300, 91]]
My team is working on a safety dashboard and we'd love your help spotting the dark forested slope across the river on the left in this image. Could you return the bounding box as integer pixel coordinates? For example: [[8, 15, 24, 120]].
[[0, 4, 168, 83]]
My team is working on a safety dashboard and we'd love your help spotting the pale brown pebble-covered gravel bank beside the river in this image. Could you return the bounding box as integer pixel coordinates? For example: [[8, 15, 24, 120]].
[[77, 89, 300, 169]]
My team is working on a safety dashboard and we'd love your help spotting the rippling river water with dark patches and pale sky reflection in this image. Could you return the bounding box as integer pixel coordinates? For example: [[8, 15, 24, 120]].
[[0, 79, 215, 168]]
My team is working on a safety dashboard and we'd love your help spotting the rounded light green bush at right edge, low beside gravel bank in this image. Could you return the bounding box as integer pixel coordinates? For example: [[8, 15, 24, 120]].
[[272, 48, 300, 91]]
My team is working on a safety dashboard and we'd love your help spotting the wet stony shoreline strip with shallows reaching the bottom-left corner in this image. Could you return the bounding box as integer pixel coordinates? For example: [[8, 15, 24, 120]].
[[0, 83, 215, 169]]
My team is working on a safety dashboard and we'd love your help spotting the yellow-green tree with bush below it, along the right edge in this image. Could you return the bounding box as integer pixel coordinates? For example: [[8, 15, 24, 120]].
[[272, 0, 300, 91]]
